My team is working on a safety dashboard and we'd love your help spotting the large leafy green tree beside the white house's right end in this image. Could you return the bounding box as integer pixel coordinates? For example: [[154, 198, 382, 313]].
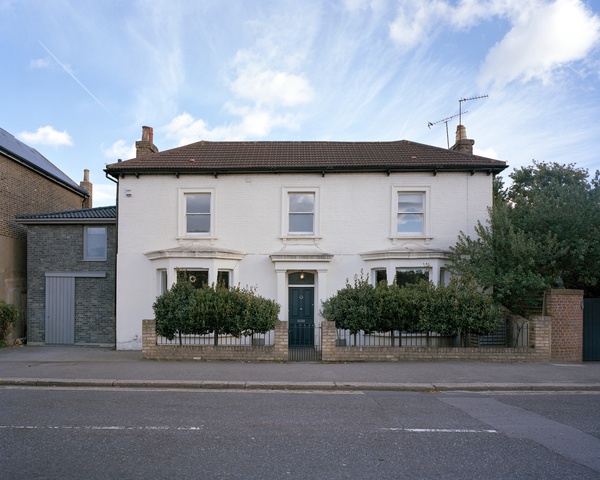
[[451, 161, 600, 313]]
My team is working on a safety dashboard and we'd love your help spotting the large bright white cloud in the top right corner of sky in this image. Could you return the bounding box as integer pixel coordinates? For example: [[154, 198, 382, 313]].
[[479, 0, 600, 86]]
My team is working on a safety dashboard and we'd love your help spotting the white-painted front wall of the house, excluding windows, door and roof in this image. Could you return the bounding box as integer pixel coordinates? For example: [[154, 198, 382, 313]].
[[117, 173, 492, 350]]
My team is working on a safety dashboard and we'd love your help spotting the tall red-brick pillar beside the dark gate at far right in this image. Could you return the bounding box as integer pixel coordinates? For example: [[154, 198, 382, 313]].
[[546, 290, 583, 362]]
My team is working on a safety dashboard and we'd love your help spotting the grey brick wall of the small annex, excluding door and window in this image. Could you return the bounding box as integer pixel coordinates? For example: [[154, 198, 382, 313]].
[[27, 224, 116, 345]]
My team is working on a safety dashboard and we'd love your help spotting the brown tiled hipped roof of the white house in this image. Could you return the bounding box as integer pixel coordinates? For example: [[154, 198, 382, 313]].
[[105, 140, 507, 176]]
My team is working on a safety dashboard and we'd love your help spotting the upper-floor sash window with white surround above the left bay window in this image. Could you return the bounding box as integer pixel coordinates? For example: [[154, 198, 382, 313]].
[[179, 189, 215, 237]]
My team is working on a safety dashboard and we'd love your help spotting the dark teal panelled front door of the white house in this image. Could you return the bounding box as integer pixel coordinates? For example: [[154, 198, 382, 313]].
[[288, 286, 315, 347]]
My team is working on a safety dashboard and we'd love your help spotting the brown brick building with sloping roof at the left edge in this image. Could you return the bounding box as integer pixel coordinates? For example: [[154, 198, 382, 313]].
[[0, 128, 91, 341]]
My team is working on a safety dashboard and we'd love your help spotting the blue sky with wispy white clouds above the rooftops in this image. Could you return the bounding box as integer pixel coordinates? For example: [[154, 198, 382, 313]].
[[0, 0, 600, 206]]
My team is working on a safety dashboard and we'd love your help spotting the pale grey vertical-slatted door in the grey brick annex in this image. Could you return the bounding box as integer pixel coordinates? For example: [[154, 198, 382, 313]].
[[45, 277, 75, 344]]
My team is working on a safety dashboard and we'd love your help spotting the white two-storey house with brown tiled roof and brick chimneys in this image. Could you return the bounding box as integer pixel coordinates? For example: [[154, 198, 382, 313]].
[[106, 126, 506, 350]]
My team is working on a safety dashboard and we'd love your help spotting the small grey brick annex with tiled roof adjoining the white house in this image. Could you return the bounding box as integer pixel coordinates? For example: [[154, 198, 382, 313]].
[[17, 206, 117, 347]]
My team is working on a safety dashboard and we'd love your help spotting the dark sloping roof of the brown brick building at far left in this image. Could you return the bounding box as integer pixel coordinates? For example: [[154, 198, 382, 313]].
[[0, 128, 89, 196]]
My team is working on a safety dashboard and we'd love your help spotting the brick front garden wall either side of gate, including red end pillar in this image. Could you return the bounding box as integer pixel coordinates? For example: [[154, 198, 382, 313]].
[[143, 290, 583, 363]]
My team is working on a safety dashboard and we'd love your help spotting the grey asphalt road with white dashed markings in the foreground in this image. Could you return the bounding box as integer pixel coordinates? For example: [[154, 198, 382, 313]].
[[0, 387, 600, 480]]
